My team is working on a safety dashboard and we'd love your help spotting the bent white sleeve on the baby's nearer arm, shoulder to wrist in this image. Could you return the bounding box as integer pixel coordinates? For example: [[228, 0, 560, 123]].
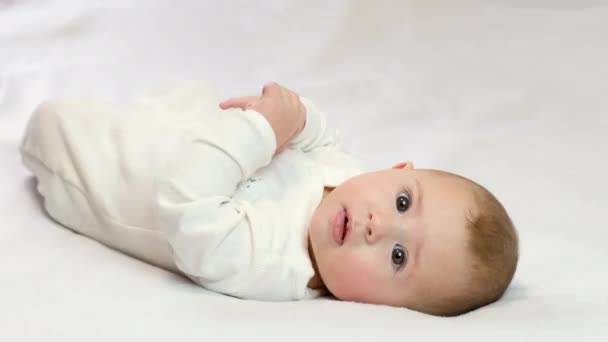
[[156, 110, 276, 290]]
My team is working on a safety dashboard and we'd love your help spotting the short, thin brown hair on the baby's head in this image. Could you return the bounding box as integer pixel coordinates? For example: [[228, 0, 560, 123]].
[[421, 170, 519, 316]]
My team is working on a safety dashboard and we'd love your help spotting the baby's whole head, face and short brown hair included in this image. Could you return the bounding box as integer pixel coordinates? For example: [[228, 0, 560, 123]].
[[310, 163, 518, 316]]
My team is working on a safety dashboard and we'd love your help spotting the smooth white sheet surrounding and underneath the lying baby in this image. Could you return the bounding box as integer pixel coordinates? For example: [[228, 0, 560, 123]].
[[0, 0, 608, 341]]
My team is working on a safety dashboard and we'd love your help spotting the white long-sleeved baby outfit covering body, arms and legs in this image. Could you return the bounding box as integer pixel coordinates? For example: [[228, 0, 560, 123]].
[[21, 83, 362, 300]]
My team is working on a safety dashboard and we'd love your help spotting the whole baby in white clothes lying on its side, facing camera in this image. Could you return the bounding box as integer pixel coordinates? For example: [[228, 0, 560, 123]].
[[21, 83, 518, 316]]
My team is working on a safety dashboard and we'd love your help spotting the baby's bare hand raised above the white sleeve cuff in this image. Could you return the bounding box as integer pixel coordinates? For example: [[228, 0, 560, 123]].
[[220, 82, 306, 153]]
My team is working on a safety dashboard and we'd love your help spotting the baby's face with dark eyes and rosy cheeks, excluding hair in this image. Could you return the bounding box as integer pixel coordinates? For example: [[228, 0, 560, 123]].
[[310, 168, 473, 307]]
